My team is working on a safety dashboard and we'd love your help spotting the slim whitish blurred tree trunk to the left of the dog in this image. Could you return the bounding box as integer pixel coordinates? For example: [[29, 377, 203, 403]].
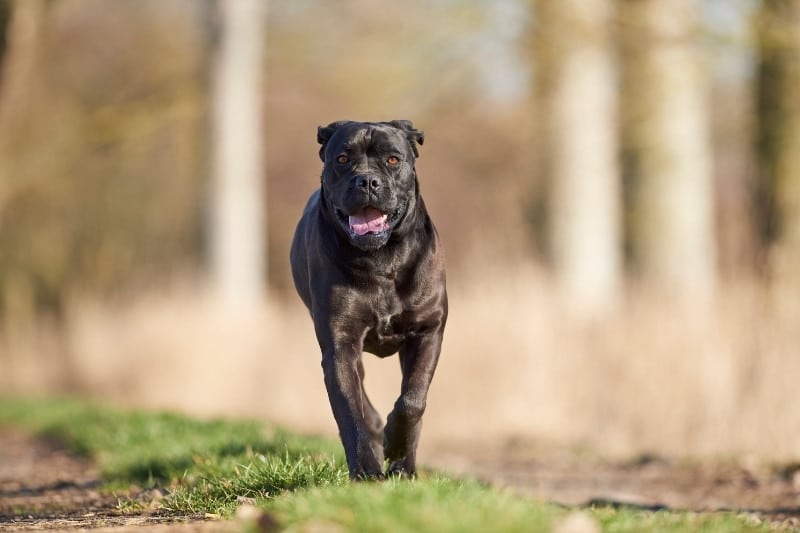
[[210, 0, 266, 309]]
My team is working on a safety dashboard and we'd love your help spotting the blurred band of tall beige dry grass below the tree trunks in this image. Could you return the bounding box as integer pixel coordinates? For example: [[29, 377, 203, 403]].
[[0, 267, 800, 460]]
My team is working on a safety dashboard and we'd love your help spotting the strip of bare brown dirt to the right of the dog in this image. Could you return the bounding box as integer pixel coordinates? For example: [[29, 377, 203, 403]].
[[429, 443, 800, 531]]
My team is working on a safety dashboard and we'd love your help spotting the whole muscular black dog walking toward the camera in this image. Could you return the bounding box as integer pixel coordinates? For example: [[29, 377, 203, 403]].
[[291, 120, 447, 479]]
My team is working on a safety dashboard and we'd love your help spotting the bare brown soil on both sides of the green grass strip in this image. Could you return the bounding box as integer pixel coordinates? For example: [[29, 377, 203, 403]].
[[0, 429, 800, 532]]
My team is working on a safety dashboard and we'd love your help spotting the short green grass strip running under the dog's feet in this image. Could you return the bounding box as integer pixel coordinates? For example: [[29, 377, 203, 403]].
[[0, 399, 768, 533]]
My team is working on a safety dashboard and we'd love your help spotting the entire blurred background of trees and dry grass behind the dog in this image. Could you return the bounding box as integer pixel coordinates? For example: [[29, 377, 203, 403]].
[[0, 0, 800, 459]]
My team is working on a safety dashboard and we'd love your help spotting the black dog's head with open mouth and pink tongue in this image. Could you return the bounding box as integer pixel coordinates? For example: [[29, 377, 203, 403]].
[[317, 120, 424, 251]]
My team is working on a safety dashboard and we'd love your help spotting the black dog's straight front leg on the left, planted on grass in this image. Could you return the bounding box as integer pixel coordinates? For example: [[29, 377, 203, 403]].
[[322, 346, 383, 479]]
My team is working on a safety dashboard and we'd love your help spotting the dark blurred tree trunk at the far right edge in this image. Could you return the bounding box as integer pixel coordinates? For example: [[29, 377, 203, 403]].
[[756, 0, 800, 275]]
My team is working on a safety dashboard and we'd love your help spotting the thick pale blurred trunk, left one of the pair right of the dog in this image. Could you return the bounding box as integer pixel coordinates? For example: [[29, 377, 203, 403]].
[[534, 0, 621, 314]]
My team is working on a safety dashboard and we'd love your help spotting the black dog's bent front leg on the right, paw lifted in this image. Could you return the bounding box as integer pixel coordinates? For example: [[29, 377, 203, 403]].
[[383, 330, 442, 476]]
